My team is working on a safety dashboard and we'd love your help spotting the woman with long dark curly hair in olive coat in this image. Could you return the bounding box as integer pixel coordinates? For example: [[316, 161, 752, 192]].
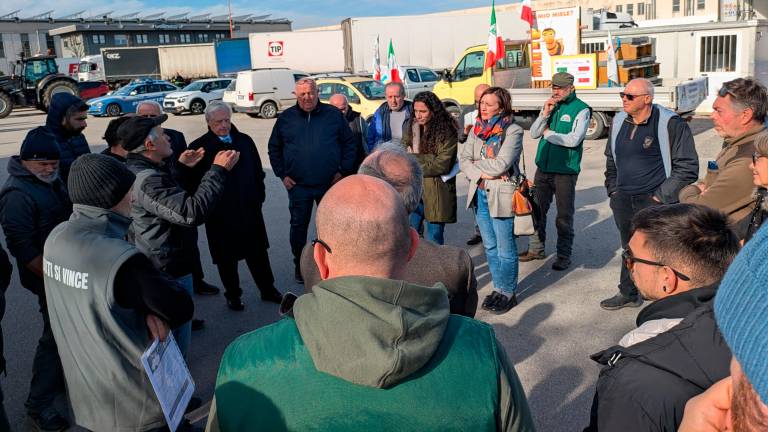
[[403, 92, 458, 244]]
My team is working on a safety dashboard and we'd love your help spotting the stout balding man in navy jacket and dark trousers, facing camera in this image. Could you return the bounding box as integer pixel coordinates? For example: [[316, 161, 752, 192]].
[[268, 78, 356, 283]]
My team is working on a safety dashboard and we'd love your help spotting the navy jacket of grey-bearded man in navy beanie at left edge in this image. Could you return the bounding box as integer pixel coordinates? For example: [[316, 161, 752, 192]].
[[0, 156, 72, 295]]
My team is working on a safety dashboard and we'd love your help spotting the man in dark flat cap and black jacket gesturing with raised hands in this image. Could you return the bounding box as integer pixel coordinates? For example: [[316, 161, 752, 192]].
[[118, 114, 239, 356]]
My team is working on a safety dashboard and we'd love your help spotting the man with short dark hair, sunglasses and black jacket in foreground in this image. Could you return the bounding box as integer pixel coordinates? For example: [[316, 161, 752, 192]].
[[586, 204, 739, 432]]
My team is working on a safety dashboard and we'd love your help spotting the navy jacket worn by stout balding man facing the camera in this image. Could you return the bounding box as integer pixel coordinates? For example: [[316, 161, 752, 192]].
[[268, 102, 357, 186]]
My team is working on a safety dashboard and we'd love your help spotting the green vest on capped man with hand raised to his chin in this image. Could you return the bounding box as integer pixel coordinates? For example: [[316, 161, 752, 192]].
[[536, 91, 589, 174]]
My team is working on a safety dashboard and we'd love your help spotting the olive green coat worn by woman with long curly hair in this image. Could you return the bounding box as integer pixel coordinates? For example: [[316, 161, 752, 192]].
[[402, 121, 459, 223]]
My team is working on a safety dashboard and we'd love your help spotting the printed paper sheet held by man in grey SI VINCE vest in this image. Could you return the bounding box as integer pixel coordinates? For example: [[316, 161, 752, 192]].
[[141, 333, 195, 431]]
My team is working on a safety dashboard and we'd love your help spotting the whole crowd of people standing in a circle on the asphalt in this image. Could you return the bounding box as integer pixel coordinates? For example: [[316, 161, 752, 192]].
[[0, 72, 768, 432]]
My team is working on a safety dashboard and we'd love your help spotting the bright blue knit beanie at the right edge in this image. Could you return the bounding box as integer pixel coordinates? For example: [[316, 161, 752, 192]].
[[715, 224, 768, 401]]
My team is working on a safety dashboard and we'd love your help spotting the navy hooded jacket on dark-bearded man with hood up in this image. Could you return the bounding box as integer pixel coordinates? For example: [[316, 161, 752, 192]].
[[45, 93, 91, 184]]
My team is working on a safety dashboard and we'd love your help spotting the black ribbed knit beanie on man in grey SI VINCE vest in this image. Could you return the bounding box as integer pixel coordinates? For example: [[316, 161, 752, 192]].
[[67, 153, 136, 209]]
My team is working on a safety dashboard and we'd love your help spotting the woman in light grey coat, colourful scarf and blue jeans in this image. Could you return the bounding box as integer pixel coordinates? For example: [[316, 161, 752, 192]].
[[460, 87, 523, 314]]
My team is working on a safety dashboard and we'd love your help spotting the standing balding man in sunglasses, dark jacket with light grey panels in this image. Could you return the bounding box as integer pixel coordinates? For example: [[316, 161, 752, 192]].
[[600, 78, 699, 310]]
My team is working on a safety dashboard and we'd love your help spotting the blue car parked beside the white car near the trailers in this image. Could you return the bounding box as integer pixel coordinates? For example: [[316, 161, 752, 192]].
[[87, 80, 179, 116]]
